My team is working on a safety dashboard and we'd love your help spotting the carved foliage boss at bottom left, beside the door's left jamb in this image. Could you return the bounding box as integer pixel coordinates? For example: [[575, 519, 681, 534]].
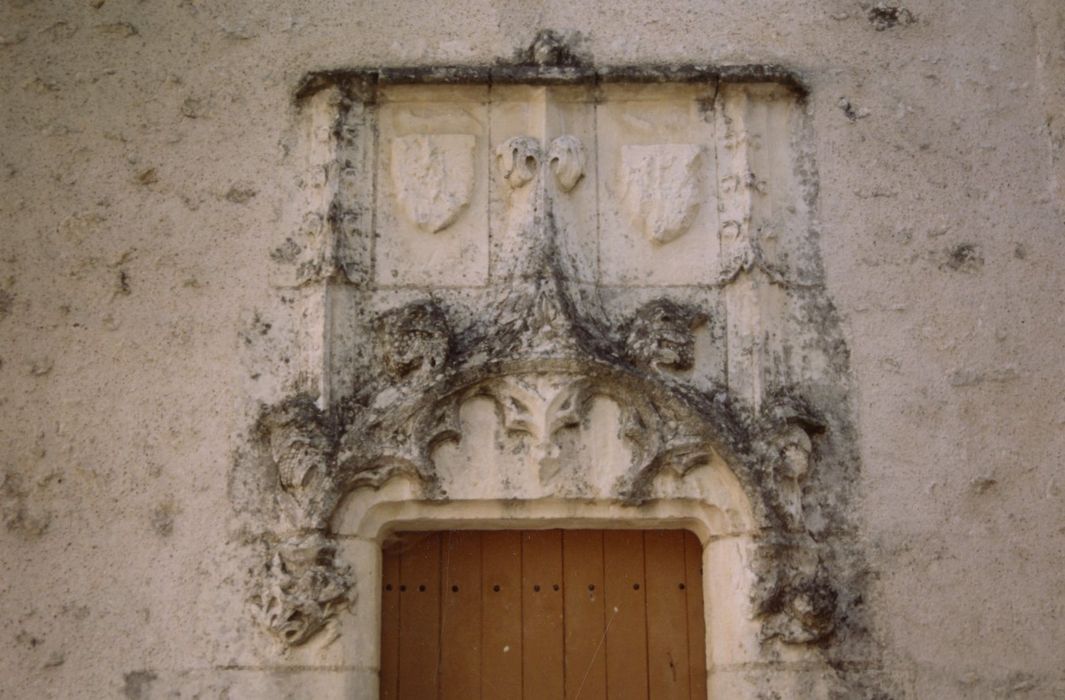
[[259, 533, 351, 646]]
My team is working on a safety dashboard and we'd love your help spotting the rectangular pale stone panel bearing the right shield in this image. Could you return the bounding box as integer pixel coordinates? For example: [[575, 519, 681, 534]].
[[599, 85, 719, 286]]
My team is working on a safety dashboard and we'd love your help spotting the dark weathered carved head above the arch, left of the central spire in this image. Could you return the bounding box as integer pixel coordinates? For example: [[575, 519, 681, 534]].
[[375, 300, 450, 379]]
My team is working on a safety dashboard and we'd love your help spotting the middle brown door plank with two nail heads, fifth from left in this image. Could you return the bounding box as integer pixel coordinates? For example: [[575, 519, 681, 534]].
[[522, 530, 564, 700]]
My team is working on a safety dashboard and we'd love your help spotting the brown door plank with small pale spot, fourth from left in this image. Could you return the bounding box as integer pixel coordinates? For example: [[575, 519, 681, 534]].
[[480, 532, 522, 700]]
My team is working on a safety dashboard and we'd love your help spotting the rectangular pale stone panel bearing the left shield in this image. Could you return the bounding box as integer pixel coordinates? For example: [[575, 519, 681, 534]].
[[374, 86, 489, 287]]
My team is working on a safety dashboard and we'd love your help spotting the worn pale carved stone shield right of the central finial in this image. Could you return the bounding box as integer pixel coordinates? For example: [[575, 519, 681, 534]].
[[621, 144, 703, 243]]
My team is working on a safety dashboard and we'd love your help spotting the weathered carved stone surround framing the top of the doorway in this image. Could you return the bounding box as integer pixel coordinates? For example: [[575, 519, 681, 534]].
[[257, 37, 855, 698]]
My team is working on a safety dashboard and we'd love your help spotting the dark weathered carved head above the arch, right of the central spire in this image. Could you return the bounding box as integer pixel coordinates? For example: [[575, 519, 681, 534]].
[[626, 299, 706, 370]]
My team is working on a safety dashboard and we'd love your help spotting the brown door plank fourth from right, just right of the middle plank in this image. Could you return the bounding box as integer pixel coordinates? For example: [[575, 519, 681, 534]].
[[562, 530, 606, 700]]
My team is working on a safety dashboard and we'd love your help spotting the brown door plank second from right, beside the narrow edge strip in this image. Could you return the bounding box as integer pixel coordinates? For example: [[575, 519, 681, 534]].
[[643, 530, 691, 700]]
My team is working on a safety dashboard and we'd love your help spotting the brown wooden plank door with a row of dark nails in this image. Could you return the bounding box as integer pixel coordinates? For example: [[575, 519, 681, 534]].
[[381, 530, 706, 700]]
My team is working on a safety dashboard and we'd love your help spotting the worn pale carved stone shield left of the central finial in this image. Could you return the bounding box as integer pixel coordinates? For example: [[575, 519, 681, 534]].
[[392, 134, 476, 233]]
